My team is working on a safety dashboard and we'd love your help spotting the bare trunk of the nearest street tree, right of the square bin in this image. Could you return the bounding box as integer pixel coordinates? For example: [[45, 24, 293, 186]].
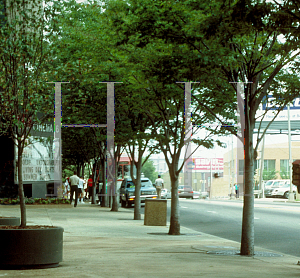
[[241, 111, 255, 256]]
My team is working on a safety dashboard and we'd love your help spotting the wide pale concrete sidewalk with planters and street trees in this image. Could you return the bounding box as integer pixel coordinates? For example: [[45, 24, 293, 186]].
[[0, 204, 300, 278]]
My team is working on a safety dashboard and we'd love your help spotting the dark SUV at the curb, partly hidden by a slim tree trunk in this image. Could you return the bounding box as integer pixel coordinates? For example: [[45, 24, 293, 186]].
[[120, 178, 157, 207]]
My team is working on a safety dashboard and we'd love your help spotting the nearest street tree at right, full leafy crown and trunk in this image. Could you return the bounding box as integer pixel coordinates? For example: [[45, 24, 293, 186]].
[[193, 1, 300, 256]]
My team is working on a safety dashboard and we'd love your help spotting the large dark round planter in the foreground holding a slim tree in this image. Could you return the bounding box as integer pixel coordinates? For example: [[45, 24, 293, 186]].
[[0, 227, 64, 269]]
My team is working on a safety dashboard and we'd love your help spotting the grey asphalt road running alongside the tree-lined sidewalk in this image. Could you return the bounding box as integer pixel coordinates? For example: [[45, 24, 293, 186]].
[[132, 199, 300, 256]]
